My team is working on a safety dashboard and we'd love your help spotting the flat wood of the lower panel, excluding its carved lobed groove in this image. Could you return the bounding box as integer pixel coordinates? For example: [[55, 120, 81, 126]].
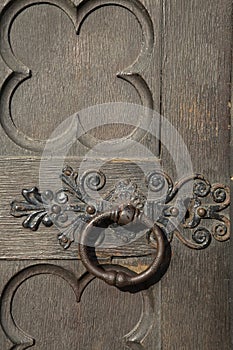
[[0, 261, 159, 350]]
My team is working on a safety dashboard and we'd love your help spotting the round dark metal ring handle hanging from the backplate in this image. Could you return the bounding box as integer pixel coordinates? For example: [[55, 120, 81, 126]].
[[79, 205, 165, 288]]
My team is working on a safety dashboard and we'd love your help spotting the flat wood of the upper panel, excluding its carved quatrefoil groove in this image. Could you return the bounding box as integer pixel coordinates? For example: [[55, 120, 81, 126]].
[[0, 0, 161, 155]]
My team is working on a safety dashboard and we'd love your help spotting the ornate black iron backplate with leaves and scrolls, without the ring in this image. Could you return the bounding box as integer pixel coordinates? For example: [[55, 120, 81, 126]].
[[11, 167, 230, 249]]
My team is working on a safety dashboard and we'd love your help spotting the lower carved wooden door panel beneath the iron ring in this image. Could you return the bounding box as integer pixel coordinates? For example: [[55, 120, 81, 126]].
[[0, 261, 160, 350]]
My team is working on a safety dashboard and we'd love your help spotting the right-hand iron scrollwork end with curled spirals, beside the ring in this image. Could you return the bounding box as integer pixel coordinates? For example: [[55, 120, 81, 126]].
[[146, 172, 230, 249]]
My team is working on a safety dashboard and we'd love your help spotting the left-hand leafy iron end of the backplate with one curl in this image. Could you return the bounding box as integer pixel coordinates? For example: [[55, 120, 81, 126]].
[[11, 166, 105, 249]]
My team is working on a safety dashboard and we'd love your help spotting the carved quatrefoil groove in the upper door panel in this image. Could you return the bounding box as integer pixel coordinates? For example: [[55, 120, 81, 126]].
[[0, 0, 155, 152]]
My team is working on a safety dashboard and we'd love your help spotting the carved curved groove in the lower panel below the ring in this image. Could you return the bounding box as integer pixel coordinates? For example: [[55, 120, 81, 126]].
[[0, 264, 154, 350]]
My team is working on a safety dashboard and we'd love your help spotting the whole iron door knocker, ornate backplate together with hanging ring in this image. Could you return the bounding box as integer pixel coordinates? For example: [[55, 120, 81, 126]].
[[11, 167, 230, 288]]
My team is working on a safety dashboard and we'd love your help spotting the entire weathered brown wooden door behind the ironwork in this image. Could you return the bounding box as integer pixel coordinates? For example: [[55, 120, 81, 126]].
[[0, 0, 232, 350]]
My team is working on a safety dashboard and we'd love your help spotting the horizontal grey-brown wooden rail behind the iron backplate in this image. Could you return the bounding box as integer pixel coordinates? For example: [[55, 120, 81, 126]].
[[0, 158, 160, 259]]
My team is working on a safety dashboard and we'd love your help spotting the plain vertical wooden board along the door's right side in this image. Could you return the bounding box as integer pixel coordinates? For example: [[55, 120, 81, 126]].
[[161, 0, 232, 350]]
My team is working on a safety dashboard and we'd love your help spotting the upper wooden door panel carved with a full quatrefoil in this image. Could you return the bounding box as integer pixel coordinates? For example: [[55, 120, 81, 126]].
[[1, 0, 161, 156]]
